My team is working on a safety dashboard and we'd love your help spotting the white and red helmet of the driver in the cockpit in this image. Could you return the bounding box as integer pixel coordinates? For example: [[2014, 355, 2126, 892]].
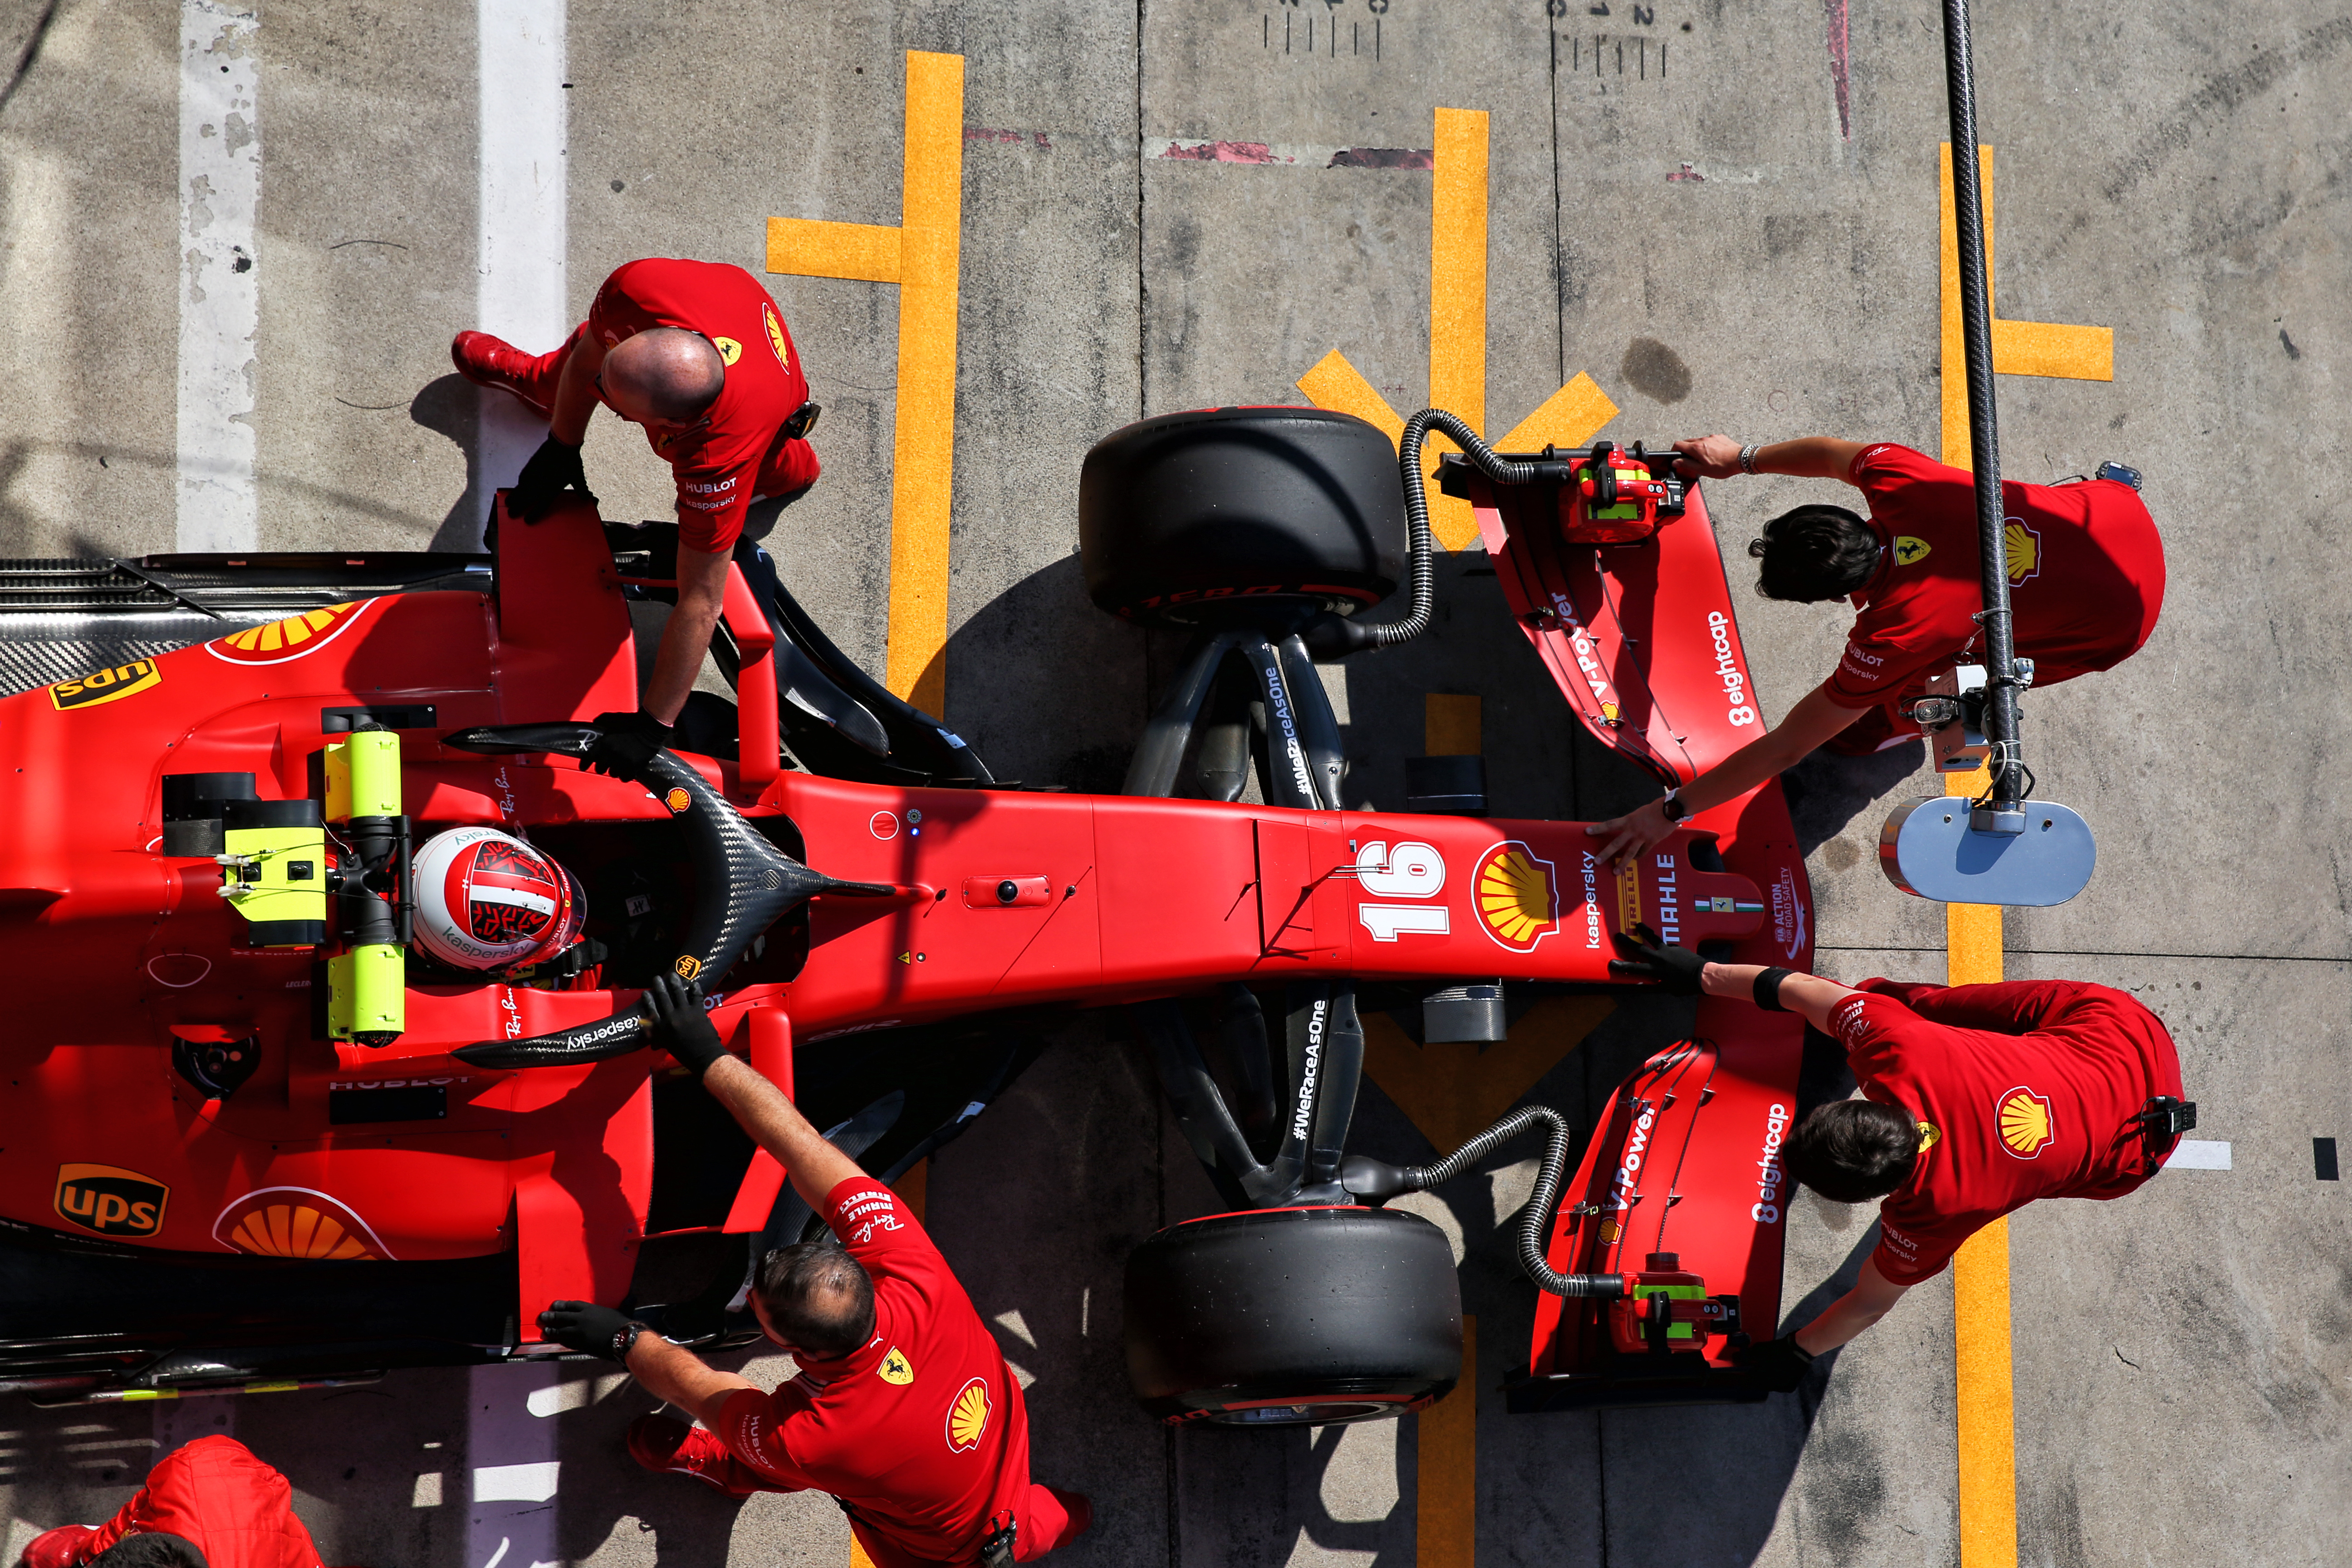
[[414, 828, 588, 973]]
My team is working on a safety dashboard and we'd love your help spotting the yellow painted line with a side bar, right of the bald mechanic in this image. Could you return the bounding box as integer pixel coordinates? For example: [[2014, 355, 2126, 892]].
[[767, 49, 964, 715]]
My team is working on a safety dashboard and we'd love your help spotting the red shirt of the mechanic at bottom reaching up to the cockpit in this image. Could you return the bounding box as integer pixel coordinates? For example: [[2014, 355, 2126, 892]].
[[715, 1176, 1039, 1563]]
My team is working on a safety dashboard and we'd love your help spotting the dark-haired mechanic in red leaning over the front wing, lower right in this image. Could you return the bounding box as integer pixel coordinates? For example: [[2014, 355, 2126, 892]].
[[1609, 926, 2197, 1392]]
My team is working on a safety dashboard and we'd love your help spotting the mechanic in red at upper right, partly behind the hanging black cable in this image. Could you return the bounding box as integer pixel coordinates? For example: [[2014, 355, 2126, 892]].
[[1588, 435, 2164, 863]]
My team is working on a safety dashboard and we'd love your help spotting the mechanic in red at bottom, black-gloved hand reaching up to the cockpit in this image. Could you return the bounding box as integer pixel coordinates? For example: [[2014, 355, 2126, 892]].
[[539, 973, 1094, 1568]]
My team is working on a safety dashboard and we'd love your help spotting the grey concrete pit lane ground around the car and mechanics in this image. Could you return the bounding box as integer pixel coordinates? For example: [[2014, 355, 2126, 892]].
[[0, 0, 2352, 1568]]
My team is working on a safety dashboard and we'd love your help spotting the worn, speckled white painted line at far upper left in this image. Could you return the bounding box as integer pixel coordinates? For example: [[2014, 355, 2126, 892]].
[[176, 0, 261, 550]]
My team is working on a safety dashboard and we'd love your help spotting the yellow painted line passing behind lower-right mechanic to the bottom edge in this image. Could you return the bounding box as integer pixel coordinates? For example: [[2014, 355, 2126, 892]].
[[1943, 769, 2018, 1568]]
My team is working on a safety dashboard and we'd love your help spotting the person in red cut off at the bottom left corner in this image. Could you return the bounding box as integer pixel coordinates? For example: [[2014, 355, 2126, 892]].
[[19, 1436, 320, 1568]]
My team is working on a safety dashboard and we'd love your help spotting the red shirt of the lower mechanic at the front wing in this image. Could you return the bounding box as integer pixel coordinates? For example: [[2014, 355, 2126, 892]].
[[1830, 980, 2180, 1286]]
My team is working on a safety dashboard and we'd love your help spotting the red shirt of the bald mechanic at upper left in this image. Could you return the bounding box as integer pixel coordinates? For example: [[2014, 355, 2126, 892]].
[[581, 256, 816, 555]]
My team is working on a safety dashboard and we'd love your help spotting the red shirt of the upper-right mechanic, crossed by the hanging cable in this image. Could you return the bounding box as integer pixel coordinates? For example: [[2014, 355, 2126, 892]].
[[1830, 442, 2164, 708]]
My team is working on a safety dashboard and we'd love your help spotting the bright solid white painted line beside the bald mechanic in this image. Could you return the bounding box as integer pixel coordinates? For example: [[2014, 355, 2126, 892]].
[[473, 0, 574, 534]]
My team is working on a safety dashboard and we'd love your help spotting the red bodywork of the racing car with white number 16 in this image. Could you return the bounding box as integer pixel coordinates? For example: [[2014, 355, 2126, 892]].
[[0, 494, 1802, 1363]]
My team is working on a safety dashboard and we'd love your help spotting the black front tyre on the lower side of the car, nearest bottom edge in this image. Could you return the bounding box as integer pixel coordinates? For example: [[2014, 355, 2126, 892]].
[[1124, 1208, 1463, 1427]]
